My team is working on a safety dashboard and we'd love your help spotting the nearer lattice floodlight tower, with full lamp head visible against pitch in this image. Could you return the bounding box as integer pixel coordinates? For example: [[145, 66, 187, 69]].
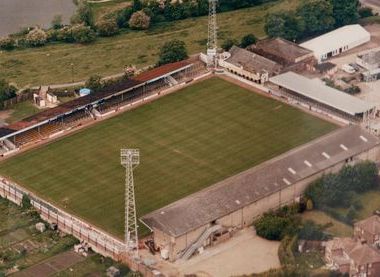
[[120, 149, 140, 258]]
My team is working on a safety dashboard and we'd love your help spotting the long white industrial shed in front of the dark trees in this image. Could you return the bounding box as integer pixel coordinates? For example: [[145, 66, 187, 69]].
[[300, 24, 371, 63]]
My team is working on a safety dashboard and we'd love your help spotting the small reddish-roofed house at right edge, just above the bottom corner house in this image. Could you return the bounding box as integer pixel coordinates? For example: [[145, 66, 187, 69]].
[[354, 215, 380, 248]]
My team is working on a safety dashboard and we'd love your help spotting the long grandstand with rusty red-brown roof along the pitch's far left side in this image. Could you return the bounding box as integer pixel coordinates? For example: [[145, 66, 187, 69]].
[[0, 60, 205, 156]]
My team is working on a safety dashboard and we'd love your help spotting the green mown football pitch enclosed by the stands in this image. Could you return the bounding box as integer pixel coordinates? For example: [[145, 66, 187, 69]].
[[0, 78, 337, 237]]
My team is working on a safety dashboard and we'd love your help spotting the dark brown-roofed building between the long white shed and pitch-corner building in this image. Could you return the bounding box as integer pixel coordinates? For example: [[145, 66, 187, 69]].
[[247, 38, 316, 71]]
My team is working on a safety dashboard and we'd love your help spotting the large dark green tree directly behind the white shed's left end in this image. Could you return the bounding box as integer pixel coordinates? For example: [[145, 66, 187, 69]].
[[297, 0, 335, 36]]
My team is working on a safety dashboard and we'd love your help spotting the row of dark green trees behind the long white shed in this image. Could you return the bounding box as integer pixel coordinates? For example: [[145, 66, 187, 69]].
[[265, 0, 371, 41]]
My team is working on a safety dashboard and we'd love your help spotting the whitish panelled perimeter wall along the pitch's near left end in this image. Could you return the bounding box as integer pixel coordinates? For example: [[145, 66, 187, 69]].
[[0, 176, 155, 276]]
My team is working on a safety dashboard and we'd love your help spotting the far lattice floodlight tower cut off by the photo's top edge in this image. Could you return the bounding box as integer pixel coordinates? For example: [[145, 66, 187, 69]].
[[207, 0, 218, 67]]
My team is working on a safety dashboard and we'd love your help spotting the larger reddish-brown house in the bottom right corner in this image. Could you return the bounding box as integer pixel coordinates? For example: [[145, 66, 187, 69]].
[[325, 238, 380, 277]]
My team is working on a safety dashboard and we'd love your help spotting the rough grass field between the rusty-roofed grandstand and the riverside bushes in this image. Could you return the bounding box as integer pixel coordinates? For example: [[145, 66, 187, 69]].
[[0, 0, 301, 86]]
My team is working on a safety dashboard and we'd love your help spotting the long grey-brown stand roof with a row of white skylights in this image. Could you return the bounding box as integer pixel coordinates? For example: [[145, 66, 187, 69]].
[[141, 126, 380, 237]]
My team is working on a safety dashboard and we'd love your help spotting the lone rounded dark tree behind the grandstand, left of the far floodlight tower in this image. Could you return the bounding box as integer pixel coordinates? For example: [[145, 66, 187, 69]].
[[158, 39, 188, 65]]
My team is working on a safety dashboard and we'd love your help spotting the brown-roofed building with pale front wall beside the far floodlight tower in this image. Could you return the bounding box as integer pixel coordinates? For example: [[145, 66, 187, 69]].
[[219, 46, 282, 84]]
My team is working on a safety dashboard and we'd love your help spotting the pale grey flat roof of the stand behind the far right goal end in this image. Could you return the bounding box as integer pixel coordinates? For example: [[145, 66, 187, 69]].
[[270, 71, 375, 116]]
